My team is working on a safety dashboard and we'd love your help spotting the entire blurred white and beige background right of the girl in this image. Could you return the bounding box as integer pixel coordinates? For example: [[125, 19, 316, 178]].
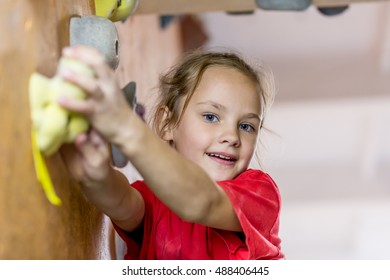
[[200, 1, 390, 259]]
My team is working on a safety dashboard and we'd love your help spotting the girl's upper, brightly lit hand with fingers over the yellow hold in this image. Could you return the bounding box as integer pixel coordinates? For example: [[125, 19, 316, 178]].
[[58, 46, 132, 142]]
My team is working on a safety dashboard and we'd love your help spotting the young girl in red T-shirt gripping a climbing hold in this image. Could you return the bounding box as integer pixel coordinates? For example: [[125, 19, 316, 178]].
[[59, 46, 283, 259]]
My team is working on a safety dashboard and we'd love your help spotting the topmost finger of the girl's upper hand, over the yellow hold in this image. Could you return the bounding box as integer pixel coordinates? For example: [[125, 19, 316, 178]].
[[63, 45, 114, 80]]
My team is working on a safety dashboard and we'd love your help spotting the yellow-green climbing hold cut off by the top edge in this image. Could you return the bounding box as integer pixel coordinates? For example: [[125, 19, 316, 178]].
[[95, 0, 139, 21]]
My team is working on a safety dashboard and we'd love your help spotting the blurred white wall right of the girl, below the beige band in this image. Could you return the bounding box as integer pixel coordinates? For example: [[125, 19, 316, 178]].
[[259, 98, 390, 259]]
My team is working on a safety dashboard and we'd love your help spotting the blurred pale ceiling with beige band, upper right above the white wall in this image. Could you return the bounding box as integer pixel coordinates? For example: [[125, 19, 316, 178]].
[[200, 1, 390, 102]]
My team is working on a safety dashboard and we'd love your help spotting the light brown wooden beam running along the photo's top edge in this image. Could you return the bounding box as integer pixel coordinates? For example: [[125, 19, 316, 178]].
[[135, 0, 389, 15]]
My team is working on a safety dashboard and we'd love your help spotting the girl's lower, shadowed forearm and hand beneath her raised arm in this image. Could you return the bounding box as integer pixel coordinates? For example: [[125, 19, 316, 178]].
[[61, 130, 144, 231]]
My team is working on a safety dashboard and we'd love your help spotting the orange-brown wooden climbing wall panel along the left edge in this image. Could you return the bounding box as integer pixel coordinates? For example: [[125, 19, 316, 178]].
[[0, 0, 111, 259]]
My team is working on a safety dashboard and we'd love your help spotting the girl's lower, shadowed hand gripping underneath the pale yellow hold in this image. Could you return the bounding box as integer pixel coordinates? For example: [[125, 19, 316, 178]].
[[60, 130, 111, 187]]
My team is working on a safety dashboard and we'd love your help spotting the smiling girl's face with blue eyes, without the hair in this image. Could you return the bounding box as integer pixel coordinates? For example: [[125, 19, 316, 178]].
[[165, 67, 260, 181]]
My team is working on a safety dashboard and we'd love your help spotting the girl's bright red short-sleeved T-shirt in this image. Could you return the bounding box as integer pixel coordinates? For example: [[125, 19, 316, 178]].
[[115, 169, 284, 260]]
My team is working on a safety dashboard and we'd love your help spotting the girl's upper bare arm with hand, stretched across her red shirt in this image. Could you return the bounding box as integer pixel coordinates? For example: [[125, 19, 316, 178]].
[[59, 46, 242, 231]]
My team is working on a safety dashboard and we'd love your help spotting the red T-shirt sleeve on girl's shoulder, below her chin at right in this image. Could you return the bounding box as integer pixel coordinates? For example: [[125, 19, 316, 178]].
[[218, 169, 284, 259]]
